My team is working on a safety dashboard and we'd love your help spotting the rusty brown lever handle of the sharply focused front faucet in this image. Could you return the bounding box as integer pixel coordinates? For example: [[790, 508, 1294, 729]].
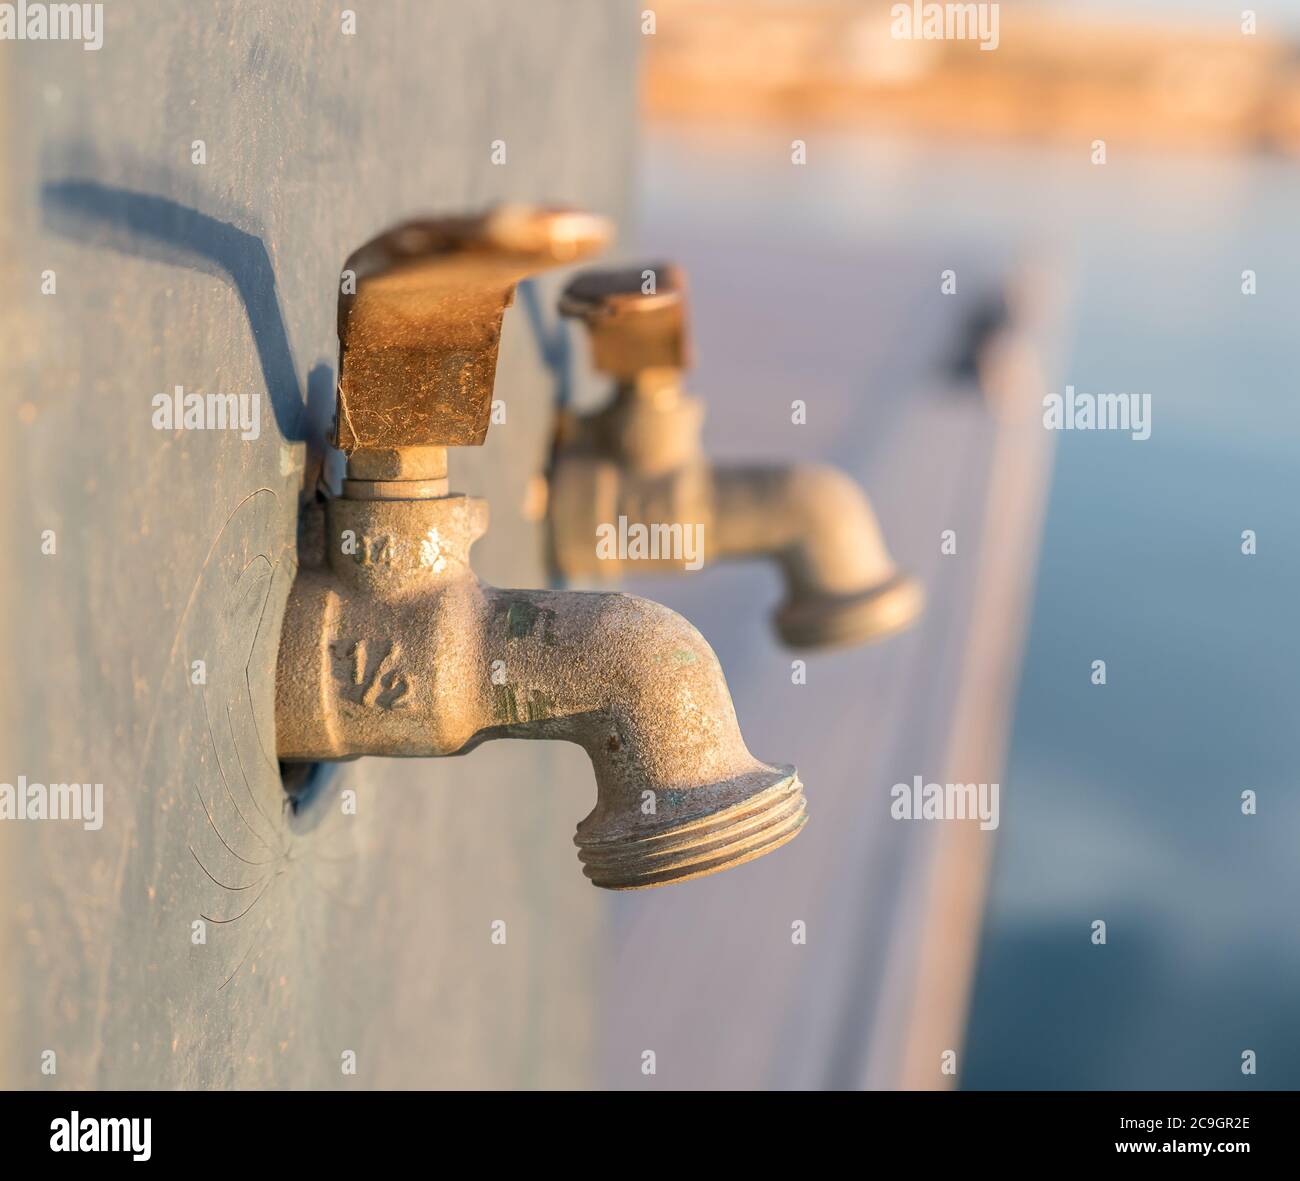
[[334, 206, 610, 455]]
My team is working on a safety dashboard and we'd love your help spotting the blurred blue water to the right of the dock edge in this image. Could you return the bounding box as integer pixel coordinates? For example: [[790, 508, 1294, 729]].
[[963, 159, 1300, 1089]]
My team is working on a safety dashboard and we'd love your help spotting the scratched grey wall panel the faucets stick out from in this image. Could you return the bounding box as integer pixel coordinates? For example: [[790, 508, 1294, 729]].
[[0, 0, 638, 1087]]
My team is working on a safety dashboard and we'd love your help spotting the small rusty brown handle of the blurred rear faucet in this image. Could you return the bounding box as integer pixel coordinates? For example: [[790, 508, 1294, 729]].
[[559, 263, 690, 381]]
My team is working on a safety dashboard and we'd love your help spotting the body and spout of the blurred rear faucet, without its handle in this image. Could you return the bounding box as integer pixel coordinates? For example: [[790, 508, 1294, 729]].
[[547, 398, 924, 648]]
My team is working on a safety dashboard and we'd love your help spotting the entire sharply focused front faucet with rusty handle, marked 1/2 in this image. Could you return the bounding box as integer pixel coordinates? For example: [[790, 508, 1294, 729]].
[[276, 207, 805, 890]]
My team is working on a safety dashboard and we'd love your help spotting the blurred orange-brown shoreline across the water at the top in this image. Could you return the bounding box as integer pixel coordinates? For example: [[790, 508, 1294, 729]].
[[642, 0, 1300, 155]]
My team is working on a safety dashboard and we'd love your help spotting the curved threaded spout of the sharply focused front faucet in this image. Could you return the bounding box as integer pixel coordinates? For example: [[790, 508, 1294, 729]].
[[465, 588, 805, 890]]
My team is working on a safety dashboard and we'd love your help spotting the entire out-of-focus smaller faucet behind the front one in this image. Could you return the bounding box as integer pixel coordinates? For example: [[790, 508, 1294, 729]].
[[547, 264, 924, 648]]
